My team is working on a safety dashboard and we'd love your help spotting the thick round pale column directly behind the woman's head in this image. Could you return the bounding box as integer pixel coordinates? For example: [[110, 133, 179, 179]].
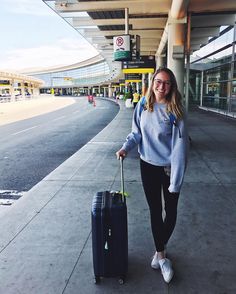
[[167, 23, 185, 97]]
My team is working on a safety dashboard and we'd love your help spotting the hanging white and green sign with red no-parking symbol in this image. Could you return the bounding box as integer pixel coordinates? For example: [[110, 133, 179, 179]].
[[113, 35, 131, 61]]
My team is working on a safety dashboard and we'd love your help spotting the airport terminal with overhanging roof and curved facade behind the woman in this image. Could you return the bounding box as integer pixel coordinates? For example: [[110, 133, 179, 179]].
[[2, 0, 236, 116]]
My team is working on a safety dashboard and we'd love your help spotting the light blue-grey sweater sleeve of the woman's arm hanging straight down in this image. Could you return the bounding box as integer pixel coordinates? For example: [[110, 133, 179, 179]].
[[168, 116, 189, 193]]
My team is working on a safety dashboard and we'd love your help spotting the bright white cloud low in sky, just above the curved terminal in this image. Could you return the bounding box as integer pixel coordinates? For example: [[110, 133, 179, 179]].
[[0, 39, 98, 72]]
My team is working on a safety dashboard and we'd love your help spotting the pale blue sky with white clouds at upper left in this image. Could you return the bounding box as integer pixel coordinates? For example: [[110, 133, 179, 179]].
[[0, 0, 98, 72]]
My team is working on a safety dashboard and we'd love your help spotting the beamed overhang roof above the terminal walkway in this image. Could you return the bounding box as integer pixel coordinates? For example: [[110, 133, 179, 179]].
[[44, 0, 236, 81]]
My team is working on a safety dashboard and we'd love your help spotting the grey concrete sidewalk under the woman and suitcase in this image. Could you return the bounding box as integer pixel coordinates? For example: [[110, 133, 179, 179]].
[[0, 100, 236, 294]]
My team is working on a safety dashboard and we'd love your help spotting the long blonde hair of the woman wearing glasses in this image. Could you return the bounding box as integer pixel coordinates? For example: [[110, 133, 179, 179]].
[[146, 68, 183, 119]]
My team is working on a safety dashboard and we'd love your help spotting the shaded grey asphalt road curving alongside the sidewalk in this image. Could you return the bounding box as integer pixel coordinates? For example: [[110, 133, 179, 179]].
[[0, 98, 119, 203]]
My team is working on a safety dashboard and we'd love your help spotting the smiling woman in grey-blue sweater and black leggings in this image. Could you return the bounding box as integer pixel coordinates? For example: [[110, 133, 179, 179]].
[[116, 68, 188, 283]]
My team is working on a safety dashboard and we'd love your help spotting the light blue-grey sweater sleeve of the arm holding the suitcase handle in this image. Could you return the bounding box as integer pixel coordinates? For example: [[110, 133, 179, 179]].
[[122, 103, 142, 152]]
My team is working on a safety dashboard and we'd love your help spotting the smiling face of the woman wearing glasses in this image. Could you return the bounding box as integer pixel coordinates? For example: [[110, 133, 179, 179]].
[[152, 71, 171, 103]]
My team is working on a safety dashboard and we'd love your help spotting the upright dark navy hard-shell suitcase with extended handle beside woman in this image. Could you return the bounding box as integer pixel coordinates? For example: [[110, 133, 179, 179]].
[[91, 159, 128, 284]]
